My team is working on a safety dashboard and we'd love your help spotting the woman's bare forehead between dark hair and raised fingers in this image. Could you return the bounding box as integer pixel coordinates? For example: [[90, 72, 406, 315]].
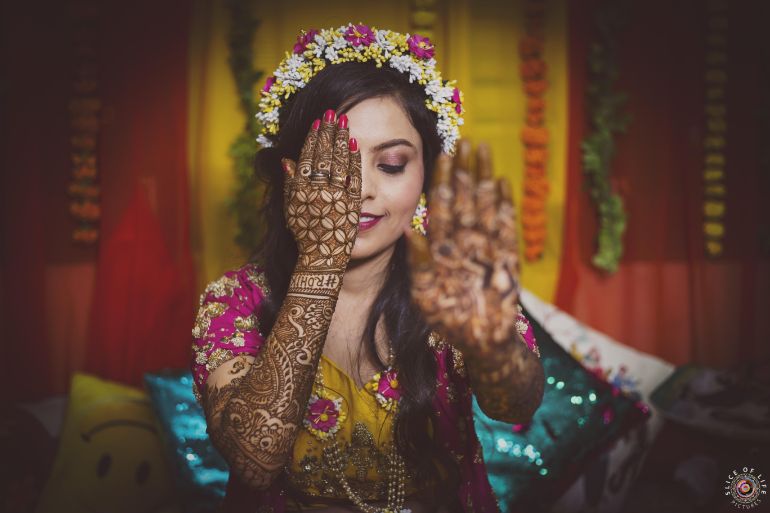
[[345, 97, 420, 148]]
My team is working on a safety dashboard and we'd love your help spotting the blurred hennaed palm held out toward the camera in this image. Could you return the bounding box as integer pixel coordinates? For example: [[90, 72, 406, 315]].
[[405, 140, 519, 356]]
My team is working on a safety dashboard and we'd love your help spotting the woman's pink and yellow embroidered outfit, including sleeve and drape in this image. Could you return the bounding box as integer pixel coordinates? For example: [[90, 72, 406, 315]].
[[192, 264, 539, 513]]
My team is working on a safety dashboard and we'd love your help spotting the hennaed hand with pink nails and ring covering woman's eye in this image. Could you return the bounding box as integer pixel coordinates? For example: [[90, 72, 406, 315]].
[[282, 110, 361, 274]]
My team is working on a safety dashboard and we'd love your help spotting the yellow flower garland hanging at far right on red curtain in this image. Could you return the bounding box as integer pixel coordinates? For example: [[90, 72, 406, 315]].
[[703, 0, 727, 257]]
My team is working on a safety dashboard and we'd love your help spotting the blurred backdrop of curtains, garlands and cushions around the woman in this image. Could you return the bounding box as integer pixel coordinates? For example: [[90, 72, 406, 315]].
[[0, 0, 770, 513]]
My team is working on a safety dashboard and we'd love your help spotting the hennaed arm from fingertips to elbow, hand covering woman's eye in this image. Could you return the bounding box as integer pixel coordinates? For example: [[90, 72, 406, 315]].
[[203, 111, 361, 489]]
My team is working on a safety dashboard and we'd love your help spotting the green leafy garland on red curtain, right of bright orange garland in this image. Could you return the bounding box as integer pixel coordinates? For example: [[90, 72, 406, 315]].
[[581, 0, 631, 273]]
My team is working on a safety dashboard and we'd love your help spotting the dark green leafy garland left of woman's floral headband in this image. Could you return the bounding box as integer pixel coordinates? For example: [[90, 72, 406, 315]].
[[227, 0, 264, 254]]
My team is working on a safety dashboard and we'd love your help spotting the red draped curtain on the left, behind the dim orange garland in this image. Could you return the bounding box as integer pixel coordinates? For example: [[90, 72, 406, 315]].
[[0, 0, 195, 401]]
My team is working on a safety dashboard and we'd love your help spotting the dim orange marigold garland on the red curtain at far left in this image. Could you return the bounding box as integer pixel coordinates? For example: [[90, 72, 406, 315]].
[[67, 3, 102, 245]]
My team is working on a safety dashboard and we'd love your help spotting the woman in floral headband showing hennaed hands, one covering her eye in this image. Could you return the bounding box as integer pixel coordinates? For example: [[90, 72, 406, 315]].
[[192, 24, 543, 513]]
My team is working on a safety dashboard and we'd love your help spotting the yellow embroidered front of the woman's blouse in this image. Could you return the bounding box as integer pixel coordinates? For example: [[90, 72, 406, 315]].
[[287, 355, 417, 511]]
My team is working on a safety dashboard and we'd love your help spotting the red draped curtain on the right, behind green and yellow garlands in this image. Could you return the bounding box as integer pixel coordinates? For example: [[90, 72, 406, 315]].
[[556, 0, 770, 367]]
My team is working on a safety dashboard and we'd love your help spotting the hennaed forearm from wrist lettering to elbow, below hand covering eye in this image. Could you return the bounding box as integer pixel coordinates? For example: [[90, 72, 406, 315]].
[[204, 272, 341, 489]]
